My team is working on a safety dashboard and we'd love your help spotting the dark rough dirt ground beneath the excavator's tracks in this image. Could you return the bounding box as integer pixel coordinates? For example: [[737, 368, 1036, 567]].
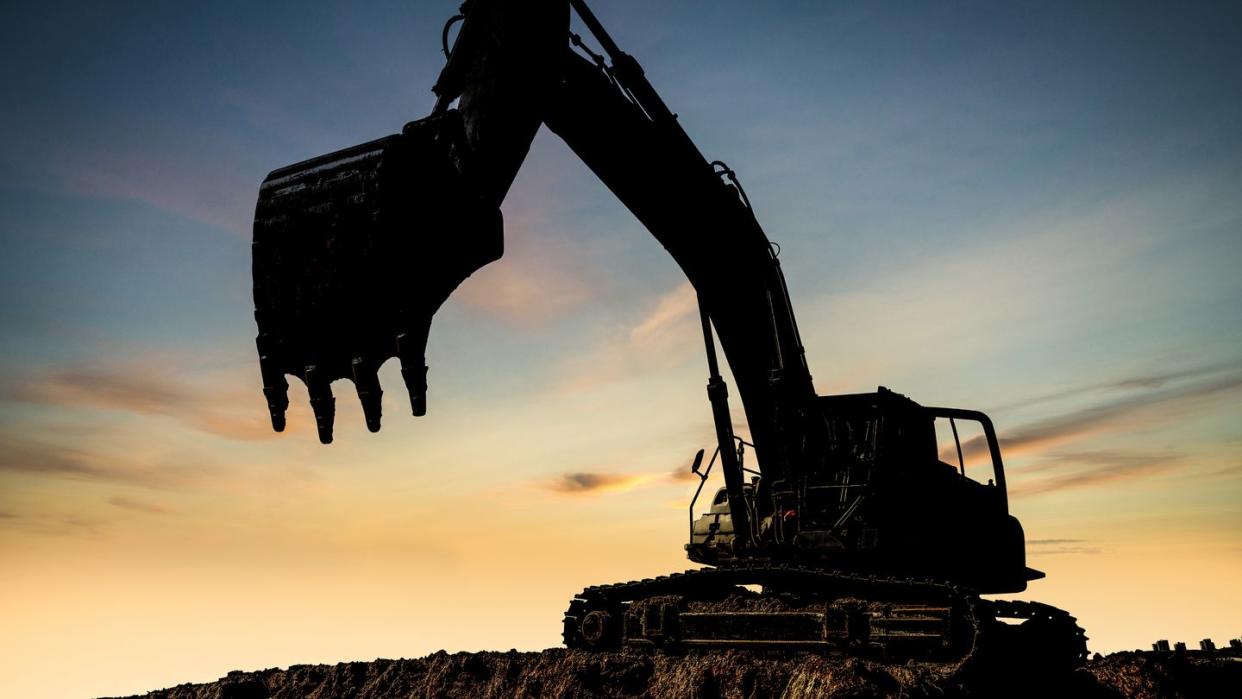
[[106, 649, 1242, 699]]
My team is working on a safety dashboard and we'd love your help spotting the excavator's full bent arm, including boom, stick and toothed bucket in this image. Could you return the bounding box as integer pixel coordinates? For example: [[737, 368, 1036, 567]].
[[253, 0, 815, 541]]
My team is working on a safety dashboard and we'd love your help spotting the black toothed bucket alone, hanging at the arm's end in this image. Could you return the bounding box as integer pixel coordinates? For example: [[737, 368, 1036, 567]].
[[252, 112, 503, 443]]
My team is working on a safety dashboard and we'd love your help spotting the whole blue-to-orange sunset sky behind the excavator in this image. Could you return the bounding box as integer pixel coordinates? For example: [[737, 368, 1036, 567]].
[[0, 0, 1242, 697]]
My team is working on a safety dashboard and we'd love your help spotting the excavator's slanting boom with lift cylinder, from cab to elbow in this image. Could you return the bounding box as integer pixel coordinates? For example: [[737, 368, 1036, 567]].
[[545, 12, 815, 541]]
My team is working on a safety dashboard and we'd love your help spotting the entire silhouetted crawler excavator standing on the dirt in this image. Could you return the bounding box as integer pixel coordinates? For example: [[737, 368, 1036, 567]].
[[252, 0, 1087, 667]]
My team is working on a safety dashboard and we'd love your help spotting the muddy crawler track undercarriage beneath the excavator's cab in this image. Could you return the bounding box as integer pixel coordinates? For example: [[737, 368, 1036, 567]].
[[563, 562, 1087, 665]]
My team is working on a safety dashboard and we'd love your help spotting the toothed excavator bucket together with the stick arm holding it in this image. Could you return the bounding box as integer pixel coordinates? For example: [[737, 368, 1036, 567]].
[[252, 0, 569, 443]]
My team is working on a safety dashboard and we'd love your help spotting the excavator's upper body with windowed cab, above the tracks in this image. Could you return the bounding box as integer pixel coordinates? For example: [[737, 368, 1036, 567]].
[[687, 387, 1043, 592]]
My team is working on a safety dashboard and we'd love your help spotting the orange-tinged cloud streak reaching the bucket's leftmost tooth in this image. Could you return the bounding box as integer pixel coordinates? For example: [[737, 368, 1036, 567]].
[[7, 365, 304, 441]]
